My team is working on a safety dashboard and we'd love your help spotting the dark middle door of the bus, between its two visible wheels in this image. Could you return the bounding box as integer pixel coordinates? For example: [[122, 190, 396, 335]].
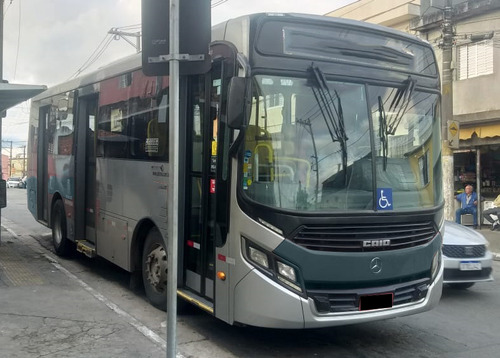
[[75, 96, 98, 243]]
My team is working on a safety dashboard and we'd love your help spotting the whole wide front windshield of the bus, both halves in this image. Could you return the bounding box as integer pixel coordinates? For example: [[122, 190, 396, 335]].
[[240, 73, 442, 211]]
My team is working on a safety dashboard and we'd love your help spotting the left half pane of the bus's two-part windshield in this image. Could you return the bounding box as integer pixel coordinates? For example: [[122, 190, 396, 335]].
[[242, 76, 372, 211]]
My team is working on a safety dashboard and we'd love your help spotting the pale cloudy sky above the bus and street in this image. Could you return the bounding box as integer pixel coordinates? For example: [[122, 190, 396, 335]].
[[2, 0, 354, 154]]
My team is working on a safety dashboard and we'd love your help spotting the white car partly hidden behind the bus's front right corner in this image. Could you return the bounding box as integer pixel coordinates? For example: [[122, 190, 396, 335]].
[[443, 221, 493, 289]]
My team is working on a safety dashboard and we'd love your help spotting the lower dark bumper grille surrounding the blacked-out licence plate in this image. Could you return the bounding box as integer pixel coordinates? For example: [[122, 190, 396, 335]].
[[307, 278, 430, 313]]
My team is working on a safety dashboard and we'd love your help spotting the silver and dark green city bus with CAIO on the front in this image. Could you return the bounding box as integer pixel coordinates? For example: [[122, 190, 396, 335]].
[[27, 13, 444, 329]]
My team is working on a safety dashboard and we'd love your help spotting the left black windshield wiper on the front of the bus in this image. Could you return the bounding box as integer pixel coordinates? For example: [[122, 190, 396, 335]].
[[308, 65, 349, 184]]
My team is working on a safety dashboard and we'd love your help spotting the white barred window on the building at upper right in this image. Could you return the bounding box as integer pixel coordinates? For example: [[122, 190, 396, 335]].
[[457, 40, 493, 80]]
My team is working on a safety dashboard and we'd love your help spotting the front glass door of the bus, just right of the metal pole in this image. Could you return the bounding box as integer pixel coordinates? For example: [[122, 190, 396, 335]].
[[183, 54, 235, 301]]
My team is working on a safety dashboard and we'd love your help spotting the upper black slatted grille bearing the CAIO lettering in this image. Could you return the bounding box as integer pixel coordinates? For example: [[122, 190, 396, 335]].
[[291, 221, 437, 252]]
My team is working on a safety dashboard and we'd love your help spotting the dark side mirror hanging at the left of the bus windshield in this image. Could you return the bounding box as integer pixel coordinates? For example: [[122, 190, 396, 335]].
[[227, 77, 247, 129]]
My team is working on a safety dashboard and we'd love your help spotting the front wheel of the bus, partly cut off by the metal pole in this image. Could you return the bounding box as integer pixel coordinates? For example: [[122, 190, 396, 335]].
[[142, 228, 168, 311]]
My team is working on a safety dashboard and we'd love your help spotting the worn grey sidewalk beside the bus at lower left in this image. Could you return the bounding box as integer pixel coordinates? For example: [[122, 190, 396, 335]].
[[0, 227, 165, 357]]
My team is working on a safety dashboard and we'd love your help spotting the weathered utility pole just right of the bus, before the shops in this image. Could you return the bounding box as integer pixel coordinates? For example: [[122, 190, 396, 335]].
[[441, 0, 455, 221]]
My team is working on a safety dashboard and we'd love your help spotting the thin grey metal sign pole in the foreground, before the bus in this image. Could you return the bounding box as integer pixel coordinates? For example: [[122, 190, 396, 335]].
[[167, 0, 180, 358]]
